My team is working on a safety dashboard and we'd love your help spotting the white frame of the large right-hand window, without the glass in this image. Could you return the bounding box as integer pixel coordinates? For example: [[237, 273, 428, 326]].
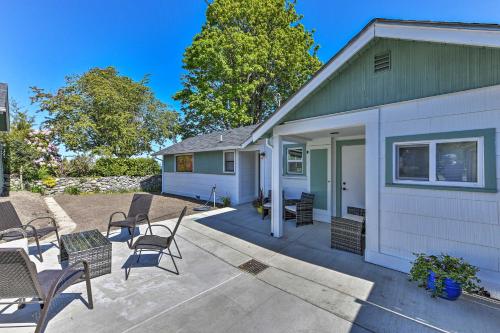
[[392, 137, 484, 188]]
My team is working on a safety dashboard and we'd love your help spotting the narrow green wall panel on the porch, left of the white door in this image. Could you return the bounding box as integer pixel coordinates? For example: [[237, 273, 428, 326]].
[[310, 149, 328, 210]]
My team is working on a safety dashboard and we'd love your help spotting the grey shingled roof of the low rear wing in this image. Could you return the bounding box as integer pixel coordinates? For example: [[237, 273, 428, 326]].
[[154, 125, 257, 155]]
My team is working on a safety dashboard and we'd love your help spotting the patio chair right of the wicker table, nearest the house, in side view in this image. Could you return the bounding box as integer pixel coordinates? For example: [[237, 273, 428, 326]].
[[125, 206, 187, 280]]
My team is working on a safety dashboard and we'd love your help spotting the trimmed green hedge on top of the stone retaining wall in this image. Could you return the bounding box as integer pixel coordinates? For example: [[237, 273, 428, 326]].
[[94, 157, 161, 177]]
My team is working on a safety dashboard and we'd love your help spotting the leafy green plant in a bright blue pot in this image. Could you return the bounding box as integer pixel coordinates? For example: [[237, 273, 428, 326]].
[[410, 253, 481, 300]]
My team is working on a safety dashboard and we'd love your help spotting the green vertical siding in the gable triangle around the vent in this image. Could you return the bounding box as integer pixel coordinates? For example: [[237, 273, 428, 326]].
[[284, 39, 500, 121]]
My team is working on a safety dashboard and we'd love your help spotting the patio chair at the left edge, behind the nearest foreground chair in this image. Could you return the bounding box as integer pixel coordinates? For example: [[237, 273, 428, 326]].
[[0, 201, 60, 261]]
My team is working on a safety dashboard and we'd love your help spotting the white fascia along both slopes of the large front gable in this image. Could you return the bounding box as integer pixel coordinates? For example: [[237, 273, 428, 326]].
[[251, 18, 500, 142]]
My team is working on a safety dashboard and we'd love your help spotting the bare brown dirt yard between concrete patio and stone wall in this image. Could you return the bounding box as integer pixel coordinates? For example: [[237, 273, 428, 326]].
[[54, 193, 211, 232]]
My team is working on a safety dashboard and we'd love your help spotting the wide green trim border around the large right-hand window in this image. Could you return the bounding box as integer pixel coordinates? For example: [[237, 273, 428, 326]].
[[385, 128, 497, 193]]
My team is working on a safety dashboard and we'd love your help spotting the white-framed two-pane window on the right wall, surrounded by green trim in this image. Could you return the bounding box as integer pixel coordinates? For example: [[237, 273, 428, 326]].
[[393, 137, 484, 187]]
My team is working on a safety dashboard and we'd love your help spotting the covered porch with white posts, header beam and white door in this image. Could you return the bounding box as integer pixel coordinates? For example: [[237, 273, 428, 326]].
[[264, 109, 380, 261]]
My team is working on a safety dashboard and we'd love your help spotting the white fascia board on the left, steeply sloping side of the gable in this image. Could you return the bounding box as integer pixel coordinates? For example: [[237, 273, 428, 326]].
[[252, 25, 375, 141]]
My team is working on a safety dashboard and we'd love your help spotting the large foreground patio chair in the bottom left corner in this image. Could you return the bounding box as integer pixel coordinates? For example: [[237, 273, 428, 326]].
[[0, 248, 93, 333]]
